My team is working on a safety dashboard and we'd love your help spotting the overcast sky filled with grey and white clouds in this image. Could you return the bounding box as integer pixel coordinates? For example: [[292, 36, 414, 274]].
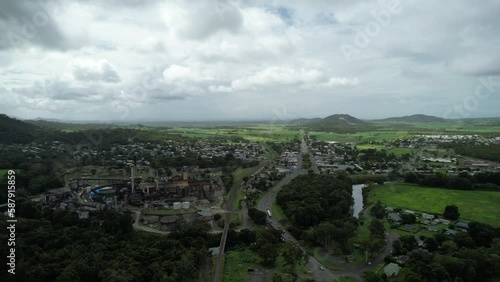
[[0, 0, 500, 121]]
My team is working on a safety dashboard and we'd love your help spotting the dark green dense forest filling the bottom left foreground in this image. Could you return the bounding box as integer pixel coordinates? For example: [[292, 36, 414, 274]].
[[0, 200, 215, 282]]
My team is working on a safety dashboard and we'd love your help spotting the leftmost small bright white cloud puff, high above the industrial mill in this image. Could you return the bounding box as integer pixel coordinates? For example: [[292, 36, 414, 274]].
[[71, 59, 120, 83]]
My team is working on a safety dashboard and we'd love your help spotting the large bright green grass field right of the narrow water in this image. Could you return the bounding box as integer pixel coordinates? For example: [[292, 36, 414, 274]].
[[372, 183, 500, 227]]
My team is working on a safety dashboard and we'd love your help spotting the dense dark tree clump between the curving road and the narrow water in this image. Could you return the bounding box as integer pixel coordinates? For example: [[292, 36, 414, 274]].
[[276, 174, 358, 254]]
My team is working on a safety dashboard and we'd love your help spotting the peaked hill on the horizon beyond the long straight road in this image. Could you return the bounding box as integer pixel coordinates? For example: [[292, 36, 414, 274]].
[[305, 114, 374, 133]]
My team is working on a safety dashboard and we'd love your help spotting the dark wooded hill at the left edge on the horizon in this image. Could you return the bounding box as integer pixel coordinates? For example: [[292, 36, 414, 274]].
[[0, 114, 40, 144]]
